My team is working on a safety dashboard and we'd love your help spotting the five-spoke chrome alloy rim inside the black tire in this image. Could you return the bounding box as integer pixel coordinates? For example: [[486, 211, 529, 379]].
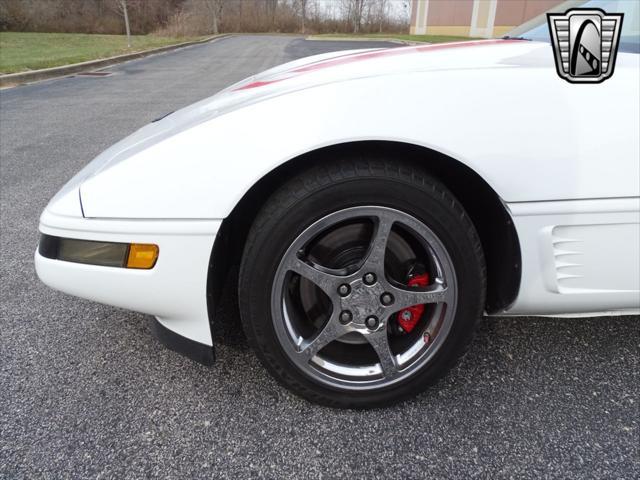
[[271, 206, 457, 390]]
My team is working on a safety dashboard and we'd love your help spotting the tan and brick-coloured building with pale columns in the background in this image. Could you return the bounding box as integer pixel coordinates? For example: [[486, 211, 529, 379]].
[[411, 0, 561, 38]]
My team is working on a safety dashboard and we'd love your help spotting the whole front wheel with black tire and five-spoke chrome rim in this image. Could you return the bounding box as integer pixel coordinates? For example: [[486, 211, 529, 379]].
[[239, 160, 485, 407]]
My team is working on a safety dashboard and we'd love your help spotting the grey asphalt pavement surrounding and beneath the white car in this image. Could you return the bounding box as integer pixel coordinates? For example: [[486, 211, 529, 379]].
[[0, 36, 640, 479]]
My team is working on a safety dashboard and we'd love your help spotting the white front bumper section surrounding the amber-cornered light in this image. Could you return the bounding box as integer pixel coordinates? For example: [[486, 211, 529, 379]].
[[35, 210, 221, 363]]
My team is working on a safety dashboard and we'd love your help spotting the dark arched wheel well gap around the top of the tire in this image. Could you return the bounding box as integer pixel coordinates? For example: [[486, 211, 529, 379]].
[[207, 141, 521, 338]]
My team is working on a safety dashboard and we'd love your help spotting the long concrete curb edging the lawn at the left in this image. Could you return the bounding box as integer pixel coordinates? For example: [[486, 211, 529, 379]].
[[0, 34, 229, 88]]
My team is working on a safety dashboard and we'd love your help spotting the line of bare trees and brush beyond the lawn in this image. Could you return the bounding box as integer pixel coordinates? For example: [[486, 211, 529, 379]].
[[0, 0, 409, 36]]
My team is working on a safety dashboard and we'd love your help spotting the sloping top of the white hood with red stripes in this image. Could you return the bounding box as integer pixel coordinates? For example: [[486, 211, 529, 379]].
[[50, 40, 552, 218]]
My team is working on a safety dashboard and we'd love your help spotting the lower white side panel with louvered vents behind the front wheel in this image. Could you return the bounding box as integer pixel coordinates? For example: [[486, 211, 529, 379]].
[[503, 198, 640, 315]]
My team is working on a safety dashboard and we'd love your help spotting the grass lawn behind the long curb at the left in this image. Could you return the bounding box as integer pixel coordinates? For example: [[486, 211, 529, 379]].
[[0, 32, 202, 73]]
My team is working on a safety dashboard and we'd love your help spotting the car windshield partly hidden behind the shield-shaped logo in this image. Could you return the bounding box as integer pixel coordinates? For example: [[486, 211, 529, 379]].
[[505, 0, 640, 53]]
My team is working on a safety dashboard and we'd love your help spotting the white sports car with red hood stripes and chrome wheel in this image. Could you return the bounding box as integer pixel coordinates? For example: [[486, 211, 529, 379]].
[[35, 1, 640, 407]]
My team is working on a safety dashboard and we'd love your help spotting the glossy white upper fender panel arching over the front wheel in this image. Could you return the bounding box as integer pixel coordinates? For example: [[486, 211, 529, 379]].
[[76, 41, 640, 218]]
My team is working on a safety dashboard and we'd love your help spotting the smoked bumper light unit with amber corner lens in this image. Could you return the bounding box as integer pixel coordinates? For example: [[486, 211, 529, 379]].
[[38, 234, 159, 270]]
